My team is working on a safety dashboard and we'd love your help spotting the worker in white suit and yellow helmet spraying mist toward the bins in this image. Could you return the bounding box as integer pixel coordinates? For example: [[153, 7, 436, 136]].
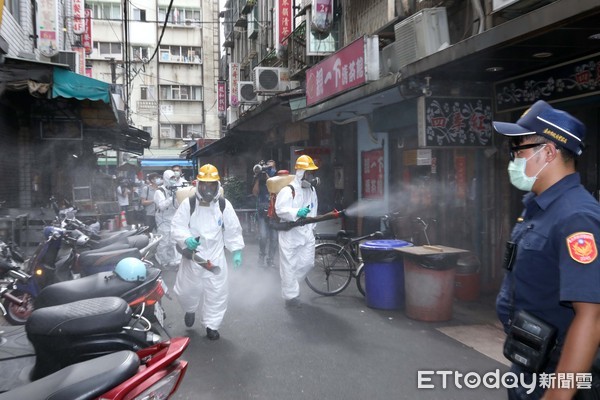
[[275, 155, 319, 307]]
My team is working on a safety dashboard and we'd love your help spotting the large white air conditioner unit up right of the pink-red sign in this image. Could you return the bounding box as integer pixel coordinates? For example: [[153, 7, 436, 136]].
[[394, 7, 450, 68]]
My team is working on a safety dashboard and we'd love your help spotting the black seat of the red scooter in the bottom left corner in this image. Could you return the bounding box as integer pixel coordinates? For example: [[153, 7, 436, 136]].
[[0, 350, 140, 400]]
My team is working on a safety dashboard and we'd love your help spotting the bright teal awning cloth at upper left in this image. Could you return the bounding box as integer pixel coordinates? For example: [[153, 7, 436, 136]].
[[52, 67, 110, 103]]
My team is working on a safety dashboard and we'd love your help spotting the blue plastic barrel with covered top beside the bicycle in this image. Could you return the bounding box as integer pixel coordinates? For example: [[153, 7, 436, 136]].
[[360, 239, 412, 310]]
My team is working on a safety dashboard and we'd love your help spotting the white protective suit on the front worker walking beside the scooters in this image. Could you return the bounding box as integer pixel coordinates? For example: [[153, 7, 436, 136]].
[[171, 190, 244, 330]]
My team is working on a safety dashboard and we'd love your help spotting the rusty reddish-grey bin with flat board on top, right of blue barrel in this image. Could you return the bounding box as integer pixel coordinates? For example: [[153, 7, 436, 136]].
[[398, 245, 466, 322]]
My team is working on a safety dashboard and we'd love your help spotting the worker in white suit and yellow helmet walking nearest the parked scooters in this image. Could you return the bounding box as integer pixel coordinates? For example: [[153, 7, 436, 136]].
[[171, 164, 244, 340]]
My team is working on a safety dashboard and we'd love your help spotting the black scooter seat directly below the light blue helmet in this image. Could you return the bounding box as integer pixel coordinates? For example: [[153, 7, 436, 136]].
[[35, 272, 140, 308]]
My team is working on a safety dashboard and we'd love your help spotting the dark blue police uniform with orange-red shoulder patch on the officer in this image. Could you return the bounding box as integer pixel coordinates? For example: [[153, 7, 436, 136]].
[[496, 173, 600, 399]]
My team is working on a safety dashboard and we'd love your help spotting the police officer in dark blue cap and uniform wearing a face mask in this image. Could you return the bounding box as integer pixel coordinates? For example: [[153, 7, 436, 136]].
[[494, 100, 600, 400]]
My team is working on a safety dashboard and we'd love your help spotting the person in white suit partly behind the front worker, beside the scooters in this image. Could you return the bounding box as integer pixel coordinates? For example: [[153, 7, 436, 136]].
[[154, 169, 181, 269]]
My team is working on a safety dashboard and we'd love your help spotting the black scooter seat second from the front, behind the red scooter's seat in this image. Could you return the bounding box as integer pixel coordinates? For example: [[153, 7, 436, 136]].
[[25, 297, 132, 338]]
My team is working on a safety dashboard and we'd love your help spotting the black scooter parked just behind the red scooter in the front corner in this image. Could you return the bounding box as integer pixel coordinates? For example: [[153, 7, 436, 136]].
[[0, 289, 161, 391]]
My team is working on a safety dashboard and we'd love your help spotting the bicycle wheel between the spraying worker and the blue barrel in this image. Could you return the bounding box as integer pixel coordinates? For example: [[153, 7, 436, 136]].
[[304, 243, 354, 296]]
